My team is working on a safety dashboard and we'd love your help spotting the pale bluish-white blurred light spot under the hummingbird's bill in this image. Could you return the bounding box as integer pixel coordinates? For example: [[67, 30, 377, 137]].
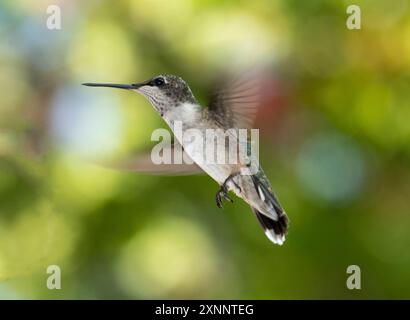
[[50, 88, 123, 157]]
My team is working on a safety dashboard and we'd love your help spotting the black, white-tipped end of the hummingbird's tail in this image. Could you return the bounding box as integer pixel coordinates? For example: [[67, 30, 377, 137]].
[[252, 207, 288, 245]]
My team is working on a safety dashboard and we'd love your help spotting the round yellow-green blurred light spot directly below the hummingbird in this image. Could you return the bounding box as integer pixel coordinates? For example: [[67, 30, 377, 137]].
[[117, 217, 223, 297]]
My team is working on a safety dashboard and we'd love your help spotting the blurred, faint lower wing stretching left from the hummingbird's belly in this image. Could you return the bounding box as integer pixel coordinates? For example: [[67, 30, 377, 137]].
[[91, 141, 204, 176]]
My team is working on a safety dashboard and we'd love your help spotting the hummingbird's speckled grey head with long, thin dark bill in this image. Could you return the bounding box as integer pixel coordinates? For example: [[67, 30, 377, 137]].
[[83, 75, 197, 116]]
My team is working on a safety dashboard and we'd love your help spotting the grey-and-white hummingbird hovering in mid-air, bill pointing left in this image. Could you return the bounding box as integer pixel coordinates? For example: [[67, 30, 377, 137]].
[[83, 75, 288, 245]]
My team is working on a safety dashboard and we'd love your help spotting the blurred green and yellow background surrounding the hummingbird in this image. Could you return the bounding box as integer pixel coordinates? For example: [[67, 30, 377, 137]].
[[0, 0, 410, 299]]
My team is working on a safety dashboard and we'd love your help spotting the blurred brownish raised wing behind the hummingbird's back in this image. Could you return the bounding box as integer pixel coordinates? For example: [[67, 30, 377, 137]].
[[208, 71, 263, 129]]
